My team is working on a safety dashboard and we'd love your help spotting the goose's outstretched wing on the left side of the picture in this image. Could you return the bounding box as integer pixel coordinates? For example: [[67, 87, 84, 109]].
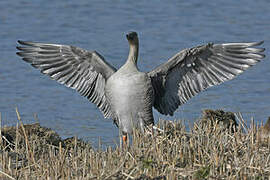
[[17, 41, 116, 118]]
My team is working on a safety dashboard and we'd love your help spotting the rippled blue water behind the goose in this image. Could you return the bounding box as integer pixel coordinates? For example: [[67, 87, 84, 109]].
[[0, 0, 270, 144]]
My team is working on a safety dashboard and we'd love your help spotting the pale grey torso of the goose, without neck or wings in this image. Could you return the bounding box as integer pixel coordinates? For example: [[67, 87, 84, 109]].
[[105, 67, 154, 132]]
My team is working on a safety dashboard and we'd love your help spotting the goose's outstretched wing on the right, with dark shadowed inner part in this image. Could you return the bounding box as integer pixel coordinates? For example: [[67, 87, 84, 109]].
[[148, 41, 264, 115]]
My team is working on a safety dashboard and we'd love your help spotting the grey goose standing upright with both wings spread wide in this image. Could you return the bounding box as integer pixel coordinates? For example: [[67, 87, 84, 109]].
[[17, 32, 265, 141]]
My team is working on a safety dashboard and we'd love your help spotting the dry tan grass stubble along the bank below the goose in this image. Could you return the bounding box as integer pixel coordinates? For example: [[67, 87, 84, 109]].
[[0, 109, 270, 179]]
